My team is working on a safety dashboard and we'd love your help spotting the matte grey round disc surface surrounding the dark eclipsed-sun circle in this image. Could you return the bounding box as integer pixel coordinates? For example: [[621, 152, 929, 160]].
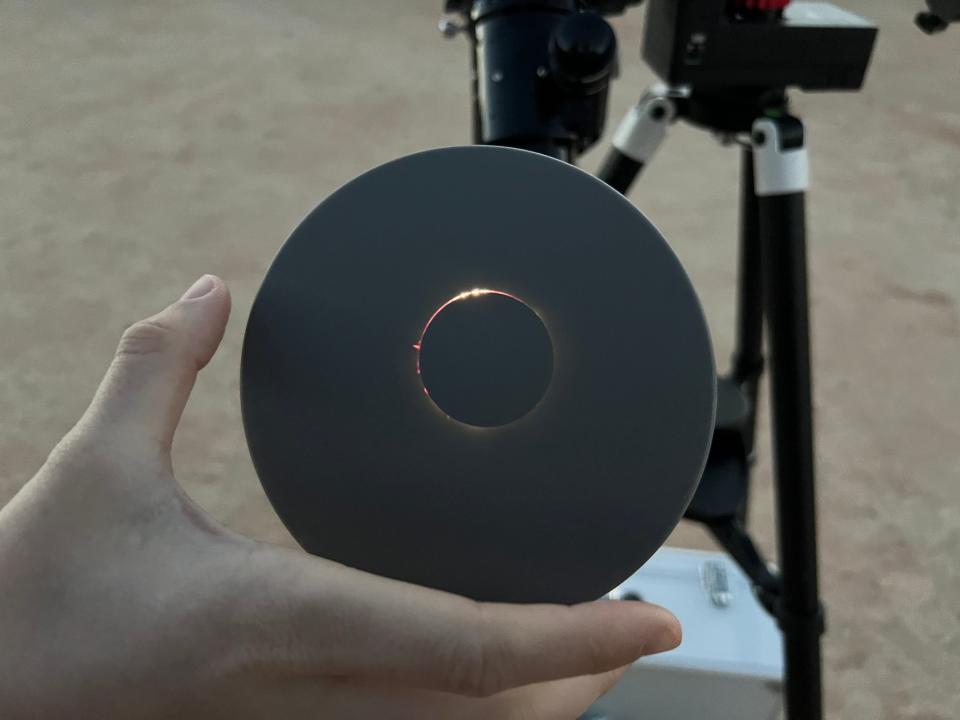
[[241, 147, 715, 602]]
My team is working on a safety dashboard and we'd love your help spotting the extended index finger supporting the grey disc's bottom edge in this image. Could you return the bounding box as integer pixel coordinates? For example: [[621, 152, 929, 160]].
[[233, 547, 680, 696]]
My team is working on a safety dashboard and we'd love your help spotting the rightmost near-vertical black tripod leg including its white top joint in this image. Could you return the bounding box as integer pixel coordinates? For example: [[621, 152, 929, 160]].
[[753, 116, 823, 720]]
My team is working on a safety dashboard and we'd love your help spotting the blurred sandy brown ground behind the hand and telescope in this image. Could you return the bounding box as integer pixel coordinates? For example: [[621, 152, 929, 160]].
[[0, 0, 960, 720]]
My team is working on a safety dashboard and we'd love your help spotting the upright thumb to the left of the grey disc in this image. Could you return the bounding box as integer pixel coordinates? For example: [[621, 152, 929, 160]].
[[81, 275, 230, 453]]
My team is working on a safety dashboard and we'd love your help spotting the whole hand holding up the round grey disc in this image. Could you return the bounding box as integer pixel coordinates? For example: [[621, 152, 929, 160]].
[[0, 275, 680, 720]]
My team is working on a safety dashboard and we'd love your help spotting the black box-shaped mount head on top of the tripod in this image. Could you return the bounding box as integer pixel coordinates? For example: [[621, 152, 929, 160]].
[[643, 0, 877, 91]]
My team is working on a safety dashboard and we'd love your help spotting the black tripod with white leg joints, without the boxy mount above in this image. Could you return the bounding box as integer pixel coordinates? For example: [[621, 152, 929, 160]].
[[598, 85, 824, 718]]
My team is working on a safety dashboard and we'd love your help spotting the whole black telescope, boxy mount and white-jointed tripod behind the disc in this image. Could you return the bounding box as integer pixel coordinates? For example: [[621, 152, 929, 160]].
[[441, 0, 876, 720]]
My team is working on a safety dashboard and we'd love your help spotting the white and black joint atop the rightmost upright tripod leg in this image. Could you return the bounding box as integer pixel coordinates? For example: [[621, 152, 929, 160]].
[[750, 115, 810, 197]]
